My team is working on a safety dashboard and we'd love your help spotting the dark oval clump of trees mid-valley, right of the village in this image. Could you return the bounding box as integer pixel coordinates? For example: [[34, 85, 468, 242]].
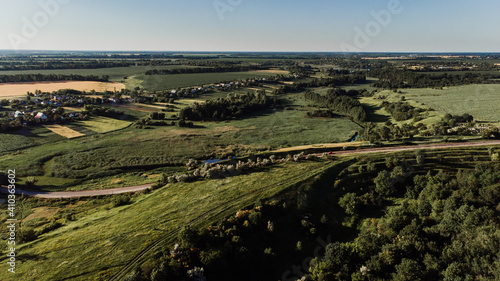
[[179, 92, 278, 121]]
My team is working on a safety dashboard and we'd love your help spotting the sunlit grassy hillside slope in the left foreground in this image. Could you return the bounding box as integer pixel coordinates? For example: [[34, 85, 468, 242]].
[[0, 162, 326, 281]]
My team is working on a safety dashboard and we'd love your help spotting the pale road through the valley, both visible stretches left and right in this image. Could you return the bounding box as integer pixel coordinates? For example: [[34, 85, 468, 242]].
[[0, 140, 500, 199]]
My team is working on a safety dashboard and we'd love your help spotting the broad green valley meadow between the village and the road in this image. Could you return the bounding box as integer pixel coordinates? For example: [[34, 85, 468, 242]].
[[0, 87, 359, 186]]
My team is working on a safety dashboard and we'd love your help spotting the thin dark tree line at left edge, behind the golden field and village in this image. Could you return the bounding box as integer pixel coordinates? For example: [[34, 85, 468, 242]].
[[0, 74, 109, 83]]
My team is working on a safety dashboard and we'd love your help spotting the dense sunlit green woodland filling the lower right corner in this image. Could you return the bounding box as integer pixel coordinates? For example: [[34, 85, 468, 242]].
[[310, 159, 500, 281]]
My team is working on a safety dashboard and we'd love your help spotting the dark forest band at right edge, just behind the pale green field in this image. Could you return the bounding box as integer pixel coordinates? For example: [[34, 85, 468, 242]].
[[370, 68, 500, 89]]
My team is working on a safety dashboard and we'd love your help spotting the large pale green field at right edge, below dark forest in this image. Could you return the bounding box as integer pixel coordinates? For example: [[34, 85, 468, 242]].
[[403, 84, 500, 123]]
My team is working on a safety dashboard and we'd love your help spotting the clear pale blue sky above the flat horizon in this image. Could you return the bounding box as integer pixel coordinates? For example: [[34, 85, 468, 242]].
[[0, 0, 500, 52]]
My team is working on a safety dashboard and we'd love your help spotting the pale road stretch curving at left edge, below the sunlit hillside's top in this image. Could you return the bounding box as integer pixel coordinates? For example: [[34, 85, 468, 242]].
[[0, 184, 152, 199]]
